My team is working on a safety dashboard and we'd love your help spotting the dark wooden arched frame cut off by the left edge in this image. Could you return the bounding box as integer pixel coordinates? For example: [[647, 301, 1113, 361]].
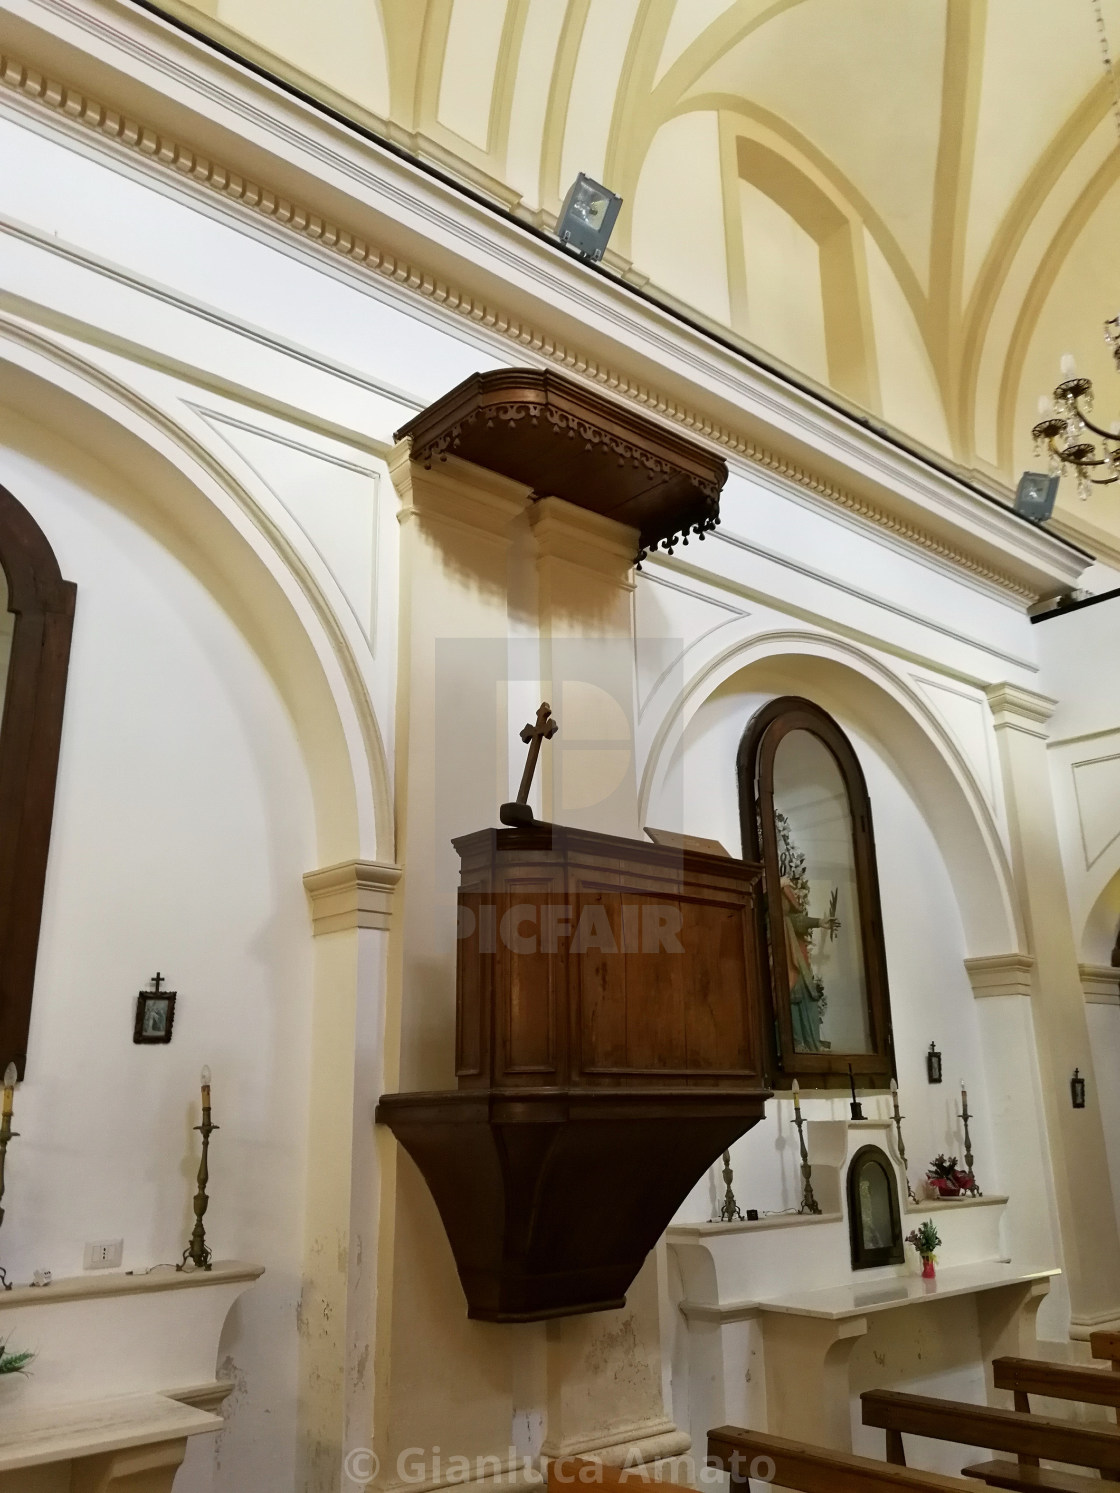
[[0, 487, 76, 1078]]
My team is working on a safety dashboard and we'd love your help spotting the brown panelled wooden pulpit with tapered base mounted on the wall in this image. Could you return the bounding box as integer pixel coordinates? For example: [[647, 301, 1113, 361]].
[[376, 823, 769, 1321]]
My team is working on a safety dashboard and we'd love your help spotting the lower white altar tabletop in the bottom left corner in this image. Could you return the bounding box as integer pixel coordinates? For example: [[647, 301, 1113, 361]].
[[0, 1394, 223, 1472]]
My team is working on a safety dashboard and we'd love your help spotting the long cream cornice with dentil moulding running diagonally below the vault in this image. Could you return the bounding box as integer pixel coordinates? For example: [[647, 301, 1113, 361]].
[[0, 0, 1086, 602]]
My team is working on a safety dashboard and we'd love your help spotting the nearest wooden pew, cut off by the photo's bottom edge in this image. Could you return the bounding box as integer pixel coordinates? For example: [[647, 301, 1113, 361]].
[[713, 1426, 985, 1493]]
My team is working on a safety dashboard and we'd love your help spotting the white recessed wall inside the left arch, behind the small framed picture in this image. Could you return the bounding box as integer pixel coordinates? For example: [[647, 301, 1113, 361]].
[[0, 417, 315, 1493]]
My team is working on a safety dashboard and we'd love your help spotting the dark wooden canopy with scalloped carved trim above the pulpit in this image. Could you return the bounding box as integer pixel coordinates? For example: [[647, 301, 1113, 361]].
[[396, 369, 727, 564]]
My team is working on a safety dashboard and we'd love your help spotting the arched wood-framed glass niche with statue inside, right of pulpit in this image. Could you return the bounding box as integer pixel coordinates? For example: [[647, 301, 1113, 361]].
[[738, 696, 895, 1088]]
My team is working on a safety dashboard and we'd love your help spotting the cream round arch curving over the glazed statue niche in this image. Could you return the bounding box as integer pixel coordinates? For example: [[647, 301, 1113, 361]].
[[639, 630, 1024, 956]]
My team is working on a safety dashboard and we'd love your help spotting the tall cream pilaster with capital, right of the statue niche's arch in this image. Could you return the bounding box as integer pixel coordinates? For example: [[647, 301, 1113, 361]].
[[987, 684, 1120, 1338]]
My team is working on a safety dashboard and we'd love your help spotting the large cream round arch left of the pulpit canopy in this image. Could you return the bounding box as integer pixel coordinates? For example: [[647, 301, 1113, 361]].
[[0, 318, 394, 864]]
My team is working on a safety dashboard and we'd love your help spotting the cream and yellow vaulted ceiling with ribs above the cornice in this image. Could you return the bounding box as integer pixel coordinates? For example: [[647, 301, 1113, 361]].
[[166, 0, 1120, 555]]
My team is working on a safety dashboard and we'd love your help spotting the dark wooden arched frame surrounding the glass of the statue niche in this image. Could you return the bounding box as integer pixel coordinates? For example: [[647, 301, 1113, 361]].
[[738, 694, 895, 1088]]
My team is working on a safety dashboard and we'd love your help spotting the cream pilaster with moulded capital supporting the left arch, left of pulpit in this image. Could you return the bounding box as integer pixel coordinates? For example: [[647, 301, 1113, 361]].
[[299, 861, 400, 1493]]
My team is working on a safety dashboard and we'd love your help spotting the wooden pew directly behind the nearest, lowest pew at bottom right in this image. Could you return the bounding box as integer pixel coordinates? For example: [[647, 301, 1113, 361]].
[[860, 1390, 1120, 1493]]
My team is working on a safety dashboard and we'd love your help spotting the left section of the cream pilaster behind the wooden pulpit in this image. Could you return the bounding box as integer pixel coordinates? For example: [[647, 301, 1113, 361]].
[[369, 443, 529, 1493]]
